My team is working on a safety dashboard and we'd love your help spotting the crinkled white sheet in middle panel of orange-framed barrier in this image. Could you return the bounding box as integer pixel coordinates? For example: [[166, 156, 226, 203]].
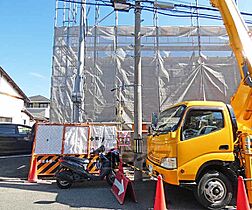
[[64, 126, 88, 154]]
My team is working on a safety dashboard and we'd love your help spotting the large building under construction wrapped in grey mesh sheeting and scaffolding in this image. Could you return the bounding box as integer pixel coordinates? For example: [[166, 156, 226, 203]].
[[50, 1, 240, 123]]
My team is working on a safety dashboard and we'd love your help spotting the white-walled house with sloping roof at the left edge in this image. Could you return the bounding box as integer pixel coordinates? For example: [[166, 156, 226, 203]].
[[0, 67, 33, 125]]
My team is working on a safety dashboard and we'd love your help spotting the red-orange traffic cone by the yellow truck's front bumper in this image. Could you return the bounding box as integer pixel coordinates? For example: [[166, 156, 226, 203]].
[[154, 175, 166, 210]]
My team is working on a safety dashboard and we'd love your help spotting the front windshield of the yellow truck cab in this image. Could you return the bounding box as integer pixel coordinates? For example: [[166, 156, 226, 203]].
[[157, 105, 186, 132]]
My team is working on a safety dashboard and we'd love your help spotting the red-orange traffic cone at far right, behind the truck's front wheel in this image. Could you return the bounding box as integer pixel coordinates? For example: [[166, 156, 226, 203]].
[[236, 176, 250, 210]]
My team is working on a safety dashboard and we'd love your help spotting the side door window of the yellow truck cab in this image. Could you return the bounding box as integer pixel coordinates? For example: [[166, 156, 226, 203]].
[[182, 109, 224, 140]]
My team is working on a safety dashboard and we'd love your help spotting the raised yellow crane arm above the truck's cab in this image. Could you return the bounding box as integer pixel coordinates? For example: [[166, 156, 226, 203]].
[[211, 0, 252, 130]]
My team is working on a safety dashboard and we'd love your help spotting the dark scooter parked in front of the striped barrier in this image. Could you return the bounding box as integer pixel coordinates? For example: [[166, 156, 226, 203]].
[[55, 145, 120, 189]]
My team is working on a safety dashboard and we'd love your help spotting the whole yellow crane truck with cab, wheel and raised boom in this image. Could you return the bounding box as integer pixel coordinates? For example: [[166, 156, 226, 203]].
[[146, 0, 252, 209]]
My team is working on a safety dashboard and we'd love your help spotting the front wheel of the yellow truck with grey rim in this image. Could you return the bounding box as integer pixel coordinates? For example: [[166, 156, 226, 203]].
[[194, 170, 233, 209]]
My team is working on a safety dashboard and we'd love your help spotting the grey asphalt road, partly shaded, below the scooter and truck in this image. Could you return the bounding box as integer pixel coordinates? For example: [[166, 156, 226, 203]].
[[0, 156, 204, 210]]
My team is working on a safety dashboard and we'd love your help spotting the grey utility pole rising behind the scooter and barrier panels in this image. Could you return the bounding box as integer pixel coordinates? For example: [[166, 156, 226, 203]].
[[72, 0, 86, 122]]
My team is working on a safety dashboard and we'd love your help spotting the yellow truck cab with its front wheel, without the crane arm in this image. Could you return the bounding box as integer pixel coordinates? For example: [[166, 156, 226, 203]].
[[146, 101, 239, 208]]
